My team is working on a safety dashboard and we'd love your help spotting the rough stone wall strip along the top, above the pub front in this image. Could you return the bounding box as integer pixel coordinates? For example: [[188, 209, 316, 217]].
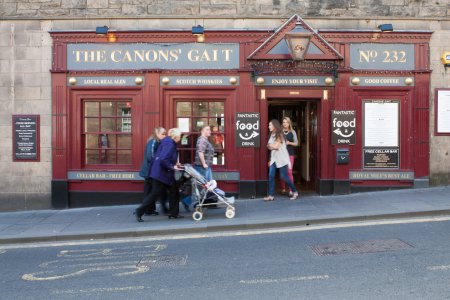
[[0, 0, 450, 19]]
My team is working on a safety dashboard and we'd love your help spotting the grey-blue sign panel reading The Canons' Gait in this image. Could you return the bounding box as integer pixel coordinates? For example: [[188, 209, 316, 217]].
[[67, 43, 239, 70]]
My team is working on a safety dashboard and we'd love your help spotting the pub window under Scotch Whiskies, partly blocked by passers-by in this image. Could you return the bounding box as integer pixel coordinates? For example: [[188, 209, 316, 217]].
[[176, 100, 225, 166]]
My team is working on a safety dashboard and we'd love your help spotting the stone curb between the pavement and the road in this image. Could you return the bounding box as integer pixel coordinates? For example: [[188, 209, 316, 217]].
[[0, 209, 450, 245]]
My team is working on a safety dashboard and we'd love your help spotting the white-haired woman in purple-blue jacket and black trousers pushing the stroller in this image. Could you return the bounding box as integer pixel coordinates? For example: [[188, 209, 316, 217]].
[[135, 128, 183, 222]]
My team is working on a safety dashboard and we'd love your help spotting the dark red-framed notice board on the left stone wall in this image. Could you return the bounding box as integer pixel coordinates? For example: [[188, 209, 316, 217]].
[[12, 115, 39, 161]]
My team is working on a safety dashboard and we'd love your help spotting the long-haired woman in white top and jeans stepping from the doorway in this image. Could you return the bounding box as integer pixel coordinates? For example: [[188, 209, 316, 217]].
[[264, 119, 298, 201]]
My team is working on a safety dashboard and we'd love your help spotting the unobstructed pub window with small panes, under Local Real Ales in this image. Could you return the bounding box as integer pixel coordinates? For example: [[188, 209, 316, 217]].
[[83, 100, 132, 165]]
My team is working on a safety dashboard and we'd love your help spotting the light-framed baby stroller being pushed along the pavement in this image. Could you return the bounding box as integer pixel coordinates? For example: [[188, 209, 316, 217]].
[[183, 164, 236, 221]]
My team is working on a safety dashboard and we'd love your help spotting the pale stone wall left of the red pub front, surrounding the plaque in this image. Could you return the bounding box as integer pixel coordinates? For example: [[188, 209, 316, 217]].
[[0, 20, 52, 210]]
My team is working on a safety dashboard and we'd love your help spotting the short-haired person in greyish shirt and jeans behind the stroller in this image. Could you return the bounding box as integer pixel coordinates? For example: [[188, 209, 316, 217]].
[[195, 125, 214, 181]]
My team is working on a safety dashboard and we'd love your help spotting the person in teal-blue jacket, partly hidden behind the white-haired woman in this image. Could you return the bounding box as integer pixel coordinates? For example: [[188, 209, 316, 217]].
[[139, 127, 168, 216]]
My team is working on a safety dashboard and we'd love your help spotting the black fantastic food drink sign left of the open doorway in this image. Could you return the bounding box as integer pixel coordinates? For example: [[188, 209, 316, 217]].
[[235, 112, 261, 148]]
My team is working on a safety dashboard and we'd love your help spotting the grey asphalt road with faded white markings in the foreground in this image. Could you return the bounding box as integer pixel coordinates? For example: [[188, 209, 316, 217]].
[[0, 221, 450, 300]]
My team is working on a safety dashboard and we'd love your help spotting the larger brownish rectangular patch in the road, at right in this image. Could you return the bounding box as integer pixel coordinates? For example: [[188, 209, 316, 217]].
[[309, 239, 413, 256]]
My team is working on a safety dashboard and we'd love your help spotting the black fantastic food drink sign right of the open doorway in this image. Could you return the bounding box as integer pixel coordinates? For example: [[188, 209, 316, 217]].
[[331, 110, 356, 145]]
